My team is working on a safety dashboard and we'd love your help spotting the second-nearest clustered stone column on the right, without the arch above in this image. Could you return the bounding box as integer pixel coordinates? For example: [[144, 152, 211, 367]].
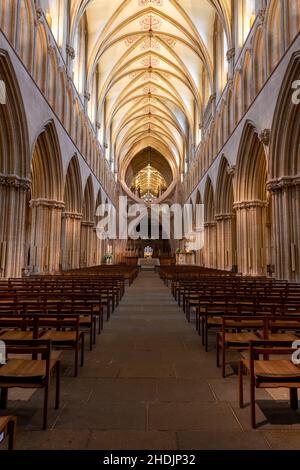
[[234, 200, 267, 276]]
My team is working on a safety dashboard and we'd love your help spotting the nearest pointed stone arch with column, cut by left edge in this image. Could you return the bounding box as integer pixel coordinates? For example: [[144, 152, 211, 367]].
[[0, 50, 30, 278]]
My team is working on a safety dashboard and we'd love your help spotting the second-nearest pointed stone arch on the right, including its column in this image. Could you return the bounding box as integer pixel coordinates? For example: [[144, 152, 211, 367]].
[[234, 123, 270, 275]]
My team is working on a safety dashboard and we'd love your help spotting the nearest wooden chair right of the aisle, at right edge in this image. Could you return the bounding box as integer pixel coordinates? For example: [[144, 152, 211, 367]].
[[238, 340, 300, 428]]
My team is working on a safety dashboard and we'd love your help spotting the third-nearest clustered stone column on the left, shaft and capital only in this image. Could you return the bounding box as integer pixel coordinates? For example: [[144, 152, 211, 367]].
[[62, 212, 82, 270]]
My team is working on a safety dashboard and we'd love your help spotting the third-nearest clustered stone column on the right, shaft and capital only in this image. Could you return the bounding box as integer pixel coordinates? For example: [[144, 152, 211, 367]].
[[216, 214, 236, 271]]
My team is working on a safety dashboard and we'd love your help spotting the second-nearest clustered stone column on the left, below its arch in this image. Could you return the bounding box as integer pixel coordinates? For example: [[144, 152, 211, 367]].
[[30, 199, 64, 273]]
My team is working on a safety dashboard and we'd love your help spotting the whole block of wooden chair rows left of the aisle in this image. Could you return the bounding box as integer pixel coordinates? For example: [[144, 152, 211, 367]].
[[0, 269, 134, 440]]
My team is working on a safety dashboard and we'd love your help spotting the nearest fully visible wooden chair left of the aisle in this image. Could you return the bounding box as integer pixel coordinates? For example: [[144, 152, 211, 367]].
[[0, 340, 60, 429]]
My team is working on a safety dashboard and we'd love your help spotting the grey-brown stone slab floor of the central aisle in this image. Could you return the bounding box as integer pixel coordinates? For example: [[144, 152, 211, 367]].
[[1, 272, 300, 450]]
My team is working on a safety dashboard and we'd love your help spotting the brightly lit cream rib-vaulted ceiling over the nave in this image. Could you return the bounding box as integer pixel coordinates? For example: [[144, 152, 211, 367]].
[[71, 0, 231, 196]]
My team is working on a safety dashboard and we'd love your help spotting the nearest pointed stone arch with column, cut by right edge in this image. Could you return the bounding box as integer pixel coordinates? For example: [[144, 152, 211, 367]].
[[268, 51, 300, 282]]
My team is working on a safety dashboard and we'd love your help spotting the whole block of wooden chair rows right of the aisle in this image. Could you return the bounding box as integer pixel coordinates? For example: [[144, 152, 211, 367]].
[[169, 271, 300, 428]]
